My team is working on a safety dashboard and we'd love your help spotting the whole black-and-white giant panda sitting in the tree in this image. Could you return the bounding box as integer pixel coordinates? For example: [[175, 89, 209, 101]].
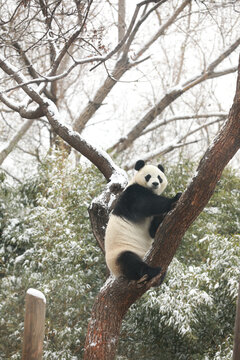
[[105, 160, 181, 281]]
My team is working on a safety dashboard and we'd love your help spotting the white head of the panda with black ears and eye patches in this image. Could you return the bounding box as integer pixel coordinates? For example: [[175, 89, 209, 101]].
[[131, 160, 168, 195]]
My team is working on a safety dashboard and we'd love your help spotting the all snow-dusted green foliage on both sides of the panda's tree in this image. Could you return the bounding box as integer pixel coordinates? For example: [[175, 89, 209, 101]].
[[0, 159, 240, 360]]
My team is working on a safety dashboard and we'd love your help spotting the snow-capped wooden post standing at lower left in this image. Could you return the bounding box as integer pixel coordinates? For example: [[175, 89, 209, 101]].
[[22, 289, 46, 360]]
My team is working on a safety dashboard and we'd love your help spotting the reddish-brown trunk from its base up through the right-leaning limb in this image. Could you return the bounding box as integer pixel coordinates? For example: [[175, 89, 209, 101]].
[[84, 58, 240, 360]]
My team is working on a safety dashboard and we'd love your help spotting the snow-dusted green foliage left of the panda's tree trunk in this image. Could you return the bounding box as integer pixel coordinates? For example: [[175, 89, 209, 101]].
[[0, 155, 105, 359]]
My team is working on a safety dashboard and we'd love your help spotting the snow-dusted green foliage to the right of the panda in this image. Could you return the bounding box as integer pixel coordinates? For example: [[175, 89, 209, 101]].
[[120, 162, 240, 360]]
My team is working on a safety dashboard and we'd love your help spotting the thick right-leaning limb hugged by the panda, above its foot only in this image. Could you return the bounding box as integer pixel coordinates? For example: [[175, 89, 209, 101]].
[[148, 60, 240, 269]]
